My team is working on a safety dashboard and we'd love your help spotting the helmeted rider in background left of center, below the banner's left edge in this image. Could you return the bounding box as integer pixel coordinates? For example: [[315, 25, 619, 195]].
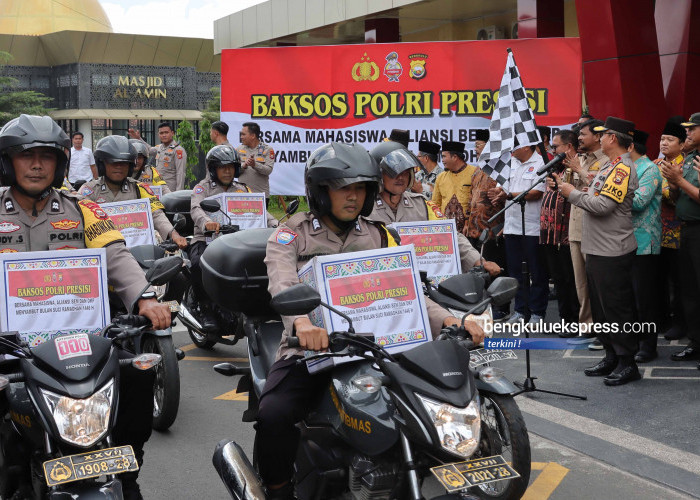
[[189, 144, 277, 330]]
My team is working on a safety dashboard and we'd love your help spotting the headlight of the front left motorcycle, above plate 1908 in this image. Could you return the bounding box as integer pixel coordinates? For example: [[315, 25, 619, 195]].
[[41, 379, 114, 447]]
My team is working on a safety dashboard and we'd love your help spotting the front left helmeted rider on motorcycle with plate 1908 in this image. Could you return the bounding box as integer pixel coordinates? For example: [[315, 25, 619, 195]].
[[0, 115, 170, 499]]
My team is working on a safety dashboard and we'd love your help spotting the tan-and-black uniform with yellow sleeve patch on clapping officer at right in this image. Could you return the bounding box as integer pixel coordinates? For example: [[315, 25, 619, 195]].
[[569, 153, 639, 356]]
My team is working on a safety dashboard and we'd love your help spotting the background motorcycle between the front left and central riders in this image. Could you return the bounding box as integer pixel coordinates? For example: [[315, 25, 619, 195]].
[[179, 199, 299, 349]]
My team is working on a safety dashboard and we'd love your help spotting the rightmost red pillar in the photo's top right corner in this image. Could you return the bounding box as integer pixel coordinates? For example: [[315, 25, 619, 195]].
[[655, 0, 700, 118]]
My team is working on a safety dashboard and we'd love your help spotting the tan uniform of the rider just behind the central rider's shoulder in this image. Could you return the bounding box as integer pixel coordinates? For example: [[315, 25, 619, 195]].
[[368, 191, 480, 271]]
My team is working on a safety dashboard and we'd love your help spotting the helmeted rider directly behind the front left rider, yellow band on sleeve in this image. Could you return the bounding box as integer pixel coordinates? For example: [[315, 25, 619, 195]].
[[78, 135, 187, 248]]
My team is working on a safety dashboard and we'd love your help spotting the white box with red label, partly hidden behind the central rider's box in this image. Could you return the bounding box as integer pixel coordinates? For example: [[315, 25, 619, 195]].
[[391, 220, 462, 283]]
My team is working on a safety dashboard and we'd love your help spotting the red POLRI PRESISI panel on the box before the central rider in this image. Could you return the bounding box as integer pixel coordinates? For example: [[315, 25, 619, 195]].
[[329, 269, 416, 309]]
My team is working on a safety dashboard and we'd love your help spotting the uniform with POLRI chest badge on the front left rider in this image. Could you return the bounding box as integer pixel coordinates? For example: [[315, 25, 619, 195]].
[[0, 187, 153, 463]]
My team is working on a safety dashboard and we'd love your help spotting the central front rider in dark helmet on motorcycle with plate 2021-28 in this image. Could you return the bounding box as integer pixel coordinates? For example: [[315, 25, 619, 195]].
[[257, 142, 484, 499]]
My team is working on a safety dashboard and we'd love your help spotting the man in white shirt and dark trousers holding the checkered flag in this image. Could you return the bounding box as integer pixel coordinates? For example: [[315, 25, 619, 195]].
[[493, 146, 549, 323]]
